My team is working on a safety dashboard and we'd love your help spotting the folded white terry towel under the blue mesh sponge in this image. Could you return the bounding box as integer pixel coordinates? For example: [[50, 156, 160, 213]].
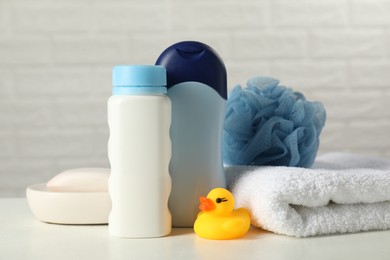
[[225, 153, 390, 237]]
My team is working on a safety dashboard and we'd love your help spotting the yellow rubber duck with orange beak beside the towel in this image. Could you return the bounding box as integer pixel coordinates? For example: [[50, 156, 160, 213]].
[[194, 188, 250, 240]]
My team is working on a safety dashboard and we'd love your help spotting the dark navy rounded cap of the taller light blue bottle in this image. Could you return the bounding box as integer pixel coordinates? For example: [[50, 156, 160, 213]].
[[156, 41, 227, 99]]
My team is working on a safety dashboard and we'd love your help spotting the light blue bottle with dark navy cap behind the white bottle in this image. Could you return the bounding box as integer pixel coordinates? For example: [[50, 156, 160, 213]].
[[156, 41, 227, 227]]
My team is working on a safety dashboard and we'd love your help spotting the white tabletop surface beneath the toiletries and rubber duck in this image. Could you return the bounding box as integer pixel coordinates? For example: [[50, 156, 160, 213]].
[[0, 198, 390, 260]]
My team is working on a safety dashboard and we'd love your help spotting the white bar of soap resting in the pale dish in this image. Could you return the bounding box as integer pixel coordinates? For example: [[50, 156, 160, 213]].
[[46, 168, 110, 192]]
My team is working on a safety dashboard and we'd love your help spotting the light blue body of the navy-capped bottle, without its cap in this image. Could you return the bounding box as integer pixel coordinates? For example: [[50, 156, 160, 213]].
[[168, 82, 226, 227]]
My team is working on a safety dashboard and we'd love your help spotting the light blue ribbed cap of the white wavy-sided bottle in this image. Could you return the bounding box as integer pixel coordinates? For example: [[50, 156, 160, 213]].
[[112, 65, 167, 95]]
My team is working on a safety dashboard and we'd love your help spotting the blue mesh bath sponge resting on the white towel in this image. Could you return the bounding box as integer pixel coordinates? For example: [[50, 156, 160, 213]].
[[223, 77, 326, 167]]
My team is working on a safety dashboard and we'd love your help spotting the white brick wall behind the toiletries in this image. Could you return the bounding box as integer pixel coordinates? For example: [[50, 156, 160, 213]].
[[0, 0, 390, 196]]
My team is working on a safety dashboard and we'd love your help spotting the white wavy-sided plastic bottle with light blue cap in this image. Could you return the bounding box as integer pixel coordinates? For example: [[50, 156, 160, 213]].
[[108, 65, 172, 238]]
